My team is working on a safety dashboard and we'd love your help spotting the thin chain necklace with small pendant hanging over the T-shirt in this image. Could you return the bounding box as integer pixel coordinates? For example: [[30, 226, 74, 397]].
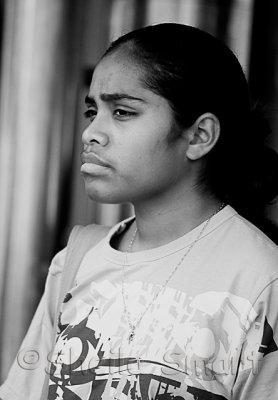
[[122, 203, 226, 344]]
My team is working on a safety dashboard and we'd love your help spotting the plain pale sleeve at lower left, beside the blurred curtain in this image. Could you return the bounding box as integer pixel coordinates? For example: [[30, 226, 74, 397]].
[[0, 249, 66, 400]]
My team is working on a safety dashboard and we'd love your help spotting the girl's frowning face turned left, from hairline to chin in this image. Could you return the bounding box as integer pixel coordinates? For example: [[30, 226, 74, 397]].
[[81, 53, 192, 204]]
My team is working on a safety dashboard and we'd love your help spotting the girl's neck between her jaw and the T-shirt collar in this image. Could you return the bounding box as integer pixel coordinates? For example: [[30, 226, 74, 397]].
[[127, 188, 221, 251]]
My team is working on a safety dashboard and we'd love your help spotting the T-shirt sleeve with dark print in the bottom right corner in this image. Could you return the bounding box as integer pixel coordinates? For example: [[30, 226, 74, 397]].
[[233, 278, 278, 400]]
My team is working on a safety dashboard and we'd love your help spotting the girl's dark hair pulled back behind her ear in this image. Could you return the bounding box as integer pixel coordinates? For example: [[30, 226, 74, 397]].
[[104, 23, 278, 238]]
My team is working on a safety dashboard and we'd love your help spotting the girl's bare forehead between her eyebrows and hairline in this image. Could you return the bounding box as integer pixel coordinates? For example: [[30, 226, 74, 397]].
[[90, 54, 146, 95]]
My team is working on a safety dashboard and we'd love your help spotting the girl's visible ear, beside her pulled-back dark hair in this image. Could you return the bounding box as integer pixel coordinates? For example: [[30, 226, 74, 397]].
[[186, 113, 220, 160]]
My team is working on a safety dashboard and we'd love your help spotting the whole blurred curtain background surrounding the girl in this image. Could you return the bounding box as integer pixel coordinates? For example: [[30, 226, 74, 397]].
[[0, 0, 278, 381]]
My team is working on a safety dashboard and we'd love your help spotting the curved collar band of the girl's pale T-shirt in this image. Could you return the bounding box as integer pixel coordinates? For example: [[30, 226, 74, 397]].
[[104, 205, 237, 265]]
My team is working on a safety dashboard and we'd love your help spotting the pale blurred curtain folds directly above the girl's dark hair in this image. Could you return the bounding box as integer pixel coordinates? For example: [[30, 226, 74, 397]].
[[145, 0, 253, 72]]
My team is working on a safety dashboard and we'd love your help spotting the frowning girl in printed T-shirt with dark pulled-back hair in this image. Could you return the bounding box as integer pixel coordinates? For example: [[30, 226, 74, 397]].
[[0, 24, 278, 400]]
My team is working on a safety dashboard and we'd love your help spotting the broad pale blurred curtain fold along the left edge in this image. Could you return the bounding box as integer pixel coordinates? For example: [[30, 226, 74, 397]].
[[0, 0, 82, 376]]
